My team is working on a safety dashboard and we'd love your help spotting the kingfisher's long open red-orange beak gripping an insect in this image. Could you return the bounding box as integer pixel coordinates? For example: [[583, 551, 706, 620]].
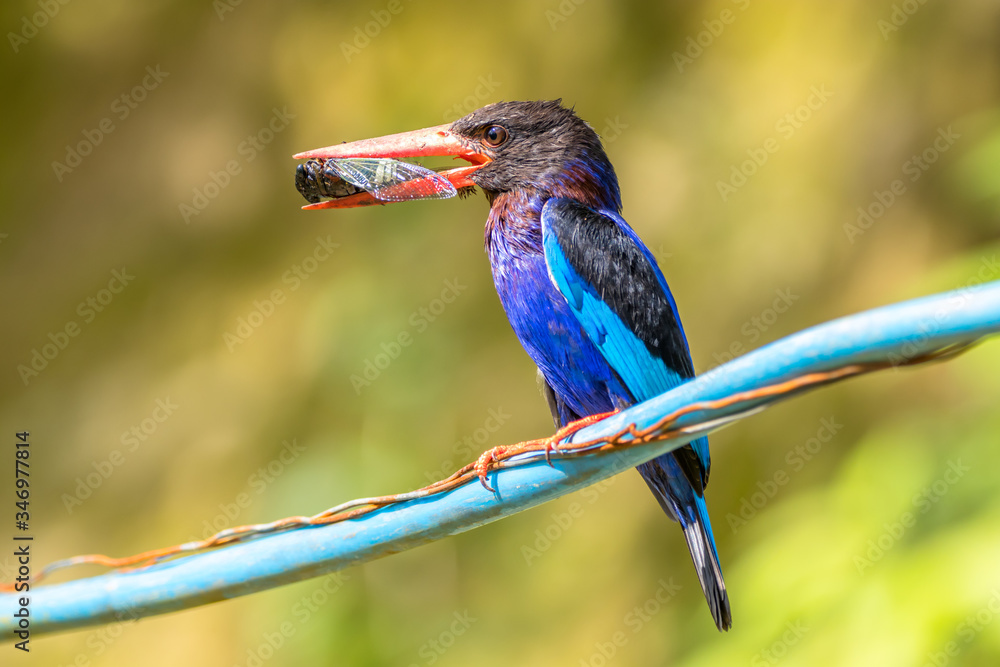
[[292, 124, 490, 210]]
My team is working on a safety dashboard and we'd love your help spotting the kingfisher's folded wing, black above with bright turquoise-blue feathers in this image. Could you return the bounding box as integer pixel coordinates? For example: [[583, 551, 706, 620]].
[[542, 198, 710, 477]]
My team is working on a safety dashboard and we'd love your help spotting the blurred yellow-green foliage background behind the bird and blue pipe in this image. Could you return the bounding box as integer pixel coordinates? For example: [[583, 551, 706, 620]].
[[0, 0, 1000, 667]]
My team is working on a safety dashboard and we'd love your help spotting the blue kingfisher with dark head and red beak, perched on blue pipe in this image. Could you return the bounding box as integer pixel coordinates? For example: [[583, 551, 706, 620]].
[[295, 100, 732, 630]]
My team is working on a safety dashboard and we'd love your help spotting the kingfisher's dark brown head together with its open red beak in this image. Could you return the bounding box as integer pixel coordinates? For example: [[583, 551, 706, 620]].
[[295, 100, 621, 210]]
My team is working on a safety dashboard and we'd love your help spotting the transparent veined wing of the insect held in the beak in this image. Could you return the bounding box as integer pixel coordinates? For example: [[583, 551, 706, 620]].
[[329, 158, 458, 202]]
